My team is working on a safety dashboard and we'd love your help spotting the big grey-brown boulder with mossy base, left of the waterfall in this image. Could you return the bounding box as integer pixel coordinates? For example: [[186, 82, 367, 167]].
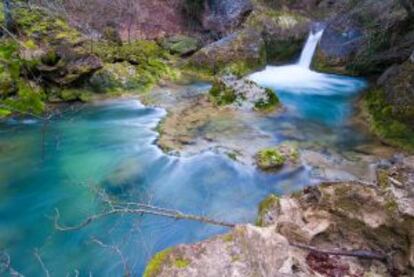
[[189, 29, 266, 76]]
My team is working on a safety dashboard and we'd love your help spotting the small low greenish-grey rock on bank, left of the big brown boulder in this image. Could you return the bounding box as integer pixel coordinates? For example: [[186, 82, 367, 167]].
[[161, 35, 201, 56]]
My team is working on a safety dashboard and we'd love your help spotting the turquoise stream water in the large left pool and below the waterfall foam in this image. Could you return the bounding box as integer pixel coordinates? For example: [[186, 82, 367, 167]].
[[0, 68, 363, 276]]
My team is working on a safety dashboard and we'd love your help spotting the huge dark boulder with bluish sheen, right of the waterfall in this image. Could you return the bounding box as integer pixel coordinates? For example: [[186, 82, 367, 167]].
[[314, 0, 414, 75]]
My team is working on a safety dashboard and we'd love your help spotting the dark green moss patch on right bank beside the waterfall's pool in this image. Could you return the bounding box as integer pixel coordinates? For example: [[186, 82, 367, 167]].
[[364, 89, 414, 151]]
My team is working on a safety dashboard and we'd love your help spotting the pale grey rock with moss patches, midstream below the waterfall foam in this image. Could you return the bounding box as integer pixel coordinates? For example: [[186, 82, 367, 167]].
[[210, 75, 279, 111]]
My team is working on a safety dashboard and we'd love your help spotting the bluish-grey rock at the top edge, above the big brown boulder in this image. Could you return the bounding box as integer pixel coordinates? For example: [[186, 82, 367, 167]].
[[201, 0, 253, 34]]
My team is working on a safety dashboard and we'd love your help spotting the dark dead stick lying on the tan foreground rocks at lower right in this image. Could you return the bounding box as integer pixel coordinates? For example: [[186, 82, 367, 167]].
[[289, 242, 388, 262]]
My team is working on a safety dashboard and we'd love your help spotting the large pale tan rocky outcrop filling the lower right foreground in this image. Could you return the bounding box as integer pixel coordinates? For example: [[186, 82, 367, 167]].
[[146, 158, 414, 276]]
